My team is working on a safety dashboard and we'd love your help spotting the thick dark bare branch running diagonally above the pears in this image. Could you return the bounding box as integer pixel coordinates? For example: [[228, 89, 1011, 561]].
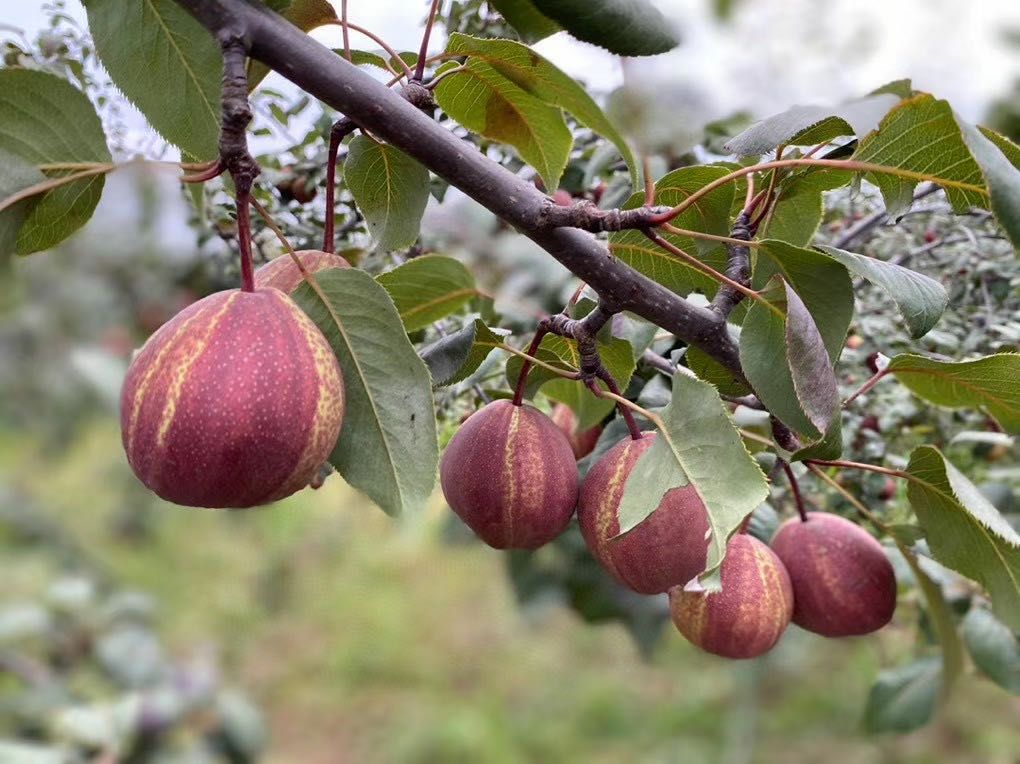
[[169, 0, 741, 373]]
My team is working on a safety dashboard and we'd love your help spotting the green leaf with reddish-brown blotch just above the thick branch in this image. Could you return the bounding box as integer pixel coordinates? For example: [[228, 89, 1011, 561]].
[[436, 58, 573, 192]]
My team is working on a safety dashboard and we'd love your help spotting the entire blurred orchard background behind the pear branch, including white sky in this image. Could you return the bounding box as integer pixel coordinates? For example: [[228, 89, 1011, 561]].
[[0, 2, 1020, 762]]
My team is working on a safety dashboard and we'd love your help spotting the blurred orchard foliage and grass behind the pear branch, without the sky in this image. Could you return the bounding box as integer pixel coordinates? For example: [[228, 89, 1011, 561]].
[[0, 0, 1020, 764]]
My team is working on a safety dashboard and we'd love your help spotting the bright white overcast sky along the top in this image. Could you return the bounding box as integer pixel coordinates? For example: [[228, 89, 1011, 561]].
[[0, 0, 1020, 142]]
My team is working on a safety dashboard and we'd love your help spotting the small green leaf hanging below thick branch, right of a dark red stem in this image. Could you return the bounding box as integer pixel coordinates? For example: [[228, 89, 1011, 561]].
[[344, 136, 428, 251]]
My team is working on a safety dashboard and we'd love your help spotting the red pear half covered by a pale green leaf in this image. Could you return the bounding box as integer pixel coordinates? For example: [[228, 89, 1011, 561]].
[[577, 432, 709, 595]]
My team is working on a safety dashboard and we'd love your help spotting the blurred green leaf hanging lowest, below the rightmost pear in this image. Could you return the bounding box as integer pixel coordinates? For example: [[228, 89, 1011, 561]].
[[864, 657, 942, 732]]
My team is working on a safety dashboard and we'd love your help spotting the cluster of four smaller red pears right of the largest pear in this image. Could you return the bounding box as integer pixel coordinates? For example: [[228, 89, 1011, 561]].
[[441, 400, 897, 658]]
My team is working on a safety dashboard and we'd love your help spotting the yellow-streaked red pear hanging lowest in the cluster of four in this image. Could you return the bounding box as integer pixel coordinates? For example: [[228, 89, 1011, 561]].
[[669, 533, 794, 658]]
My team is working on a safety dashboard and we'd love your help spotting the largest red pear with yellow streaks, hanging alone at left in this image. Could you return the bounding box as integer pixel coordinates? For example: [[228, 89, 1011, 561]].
[[120, 289, 344, 507]]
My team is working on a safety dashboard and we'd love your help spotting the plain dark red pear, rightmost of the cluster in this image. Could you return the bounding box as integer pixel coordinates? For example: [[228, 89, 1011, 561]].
[[772, 512, 896, 636]]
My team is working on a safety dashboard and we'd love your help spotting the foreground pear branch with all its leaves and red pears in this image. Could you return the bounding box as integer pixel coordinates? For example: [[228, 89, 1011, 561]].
[[0, 0, 1020, 730]]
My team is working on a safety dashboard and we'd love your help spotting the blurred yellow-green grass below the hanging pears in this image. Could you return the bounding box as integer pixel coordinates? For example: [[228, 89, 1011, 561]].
[[0, 422, 1020, 764]]
